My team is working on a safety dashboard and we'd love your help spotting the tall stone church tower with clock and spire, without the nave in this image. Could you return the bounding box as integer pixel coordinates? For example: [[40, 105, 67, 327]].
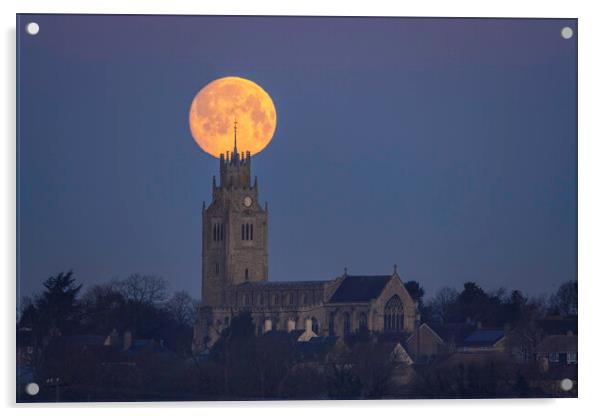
[[202, 121, 268, 306]]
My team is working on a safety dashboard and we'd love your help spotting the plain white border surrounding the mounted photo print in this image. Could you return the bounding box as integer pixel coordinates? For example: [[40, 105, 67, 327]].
[[0, 0, 602, 416]]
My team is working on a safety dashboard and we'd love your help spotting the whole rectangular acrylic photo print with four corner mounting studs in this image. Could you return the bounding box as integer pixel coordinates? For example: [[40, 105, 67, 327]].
[[16, 14, 578, 402]]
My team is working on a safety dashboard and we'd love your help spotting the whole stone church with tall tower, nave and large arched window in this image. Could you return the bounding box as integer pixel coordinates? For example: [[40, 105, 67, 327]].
[[193, 126, 420, 351]]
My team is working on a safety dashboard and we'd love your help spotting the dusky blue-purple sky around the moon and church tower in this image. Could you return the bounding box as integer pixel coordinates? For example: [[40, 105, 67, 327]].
[[17, 15, 577, 298]]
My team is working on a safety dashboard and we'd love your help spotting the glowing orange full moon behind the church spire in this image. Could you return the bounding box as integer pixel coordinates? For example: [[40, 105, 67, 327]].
[[189, 77, 276, 157]]
